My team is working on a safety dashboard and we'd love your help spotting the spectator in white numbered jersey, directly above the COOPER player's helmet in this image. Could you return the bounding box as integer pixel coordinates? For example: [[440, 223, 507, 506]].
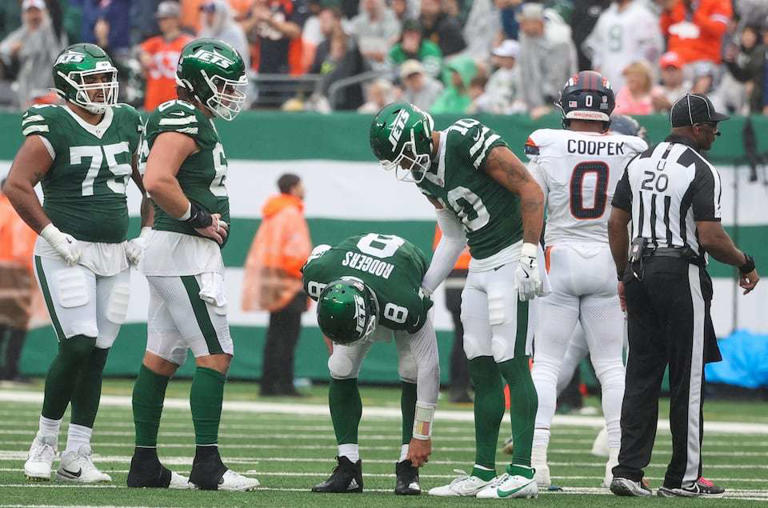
[[584, 0, 664, 90]]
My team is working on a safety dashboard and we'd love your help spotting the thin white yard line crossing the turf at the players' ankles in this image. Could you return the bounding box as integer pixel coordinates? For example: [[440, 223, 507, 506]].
[[0, 452, 768, 474]]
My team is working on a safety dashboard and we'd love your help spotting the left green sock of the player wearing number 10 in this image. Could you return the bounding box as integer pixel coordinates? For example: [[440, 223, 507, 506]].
[[469, 356, 504, 470]]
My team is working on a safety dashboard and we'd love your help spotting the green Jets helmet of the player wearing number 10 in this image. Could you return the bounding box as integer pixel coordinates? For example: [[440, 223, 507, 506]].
[[370, 103, 434, 183]]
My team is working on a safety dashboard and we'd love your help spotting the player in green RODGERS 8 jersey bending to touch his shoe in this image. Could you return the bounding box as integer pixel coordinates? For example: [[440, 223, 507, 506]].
[[302, 233, 440, 495]]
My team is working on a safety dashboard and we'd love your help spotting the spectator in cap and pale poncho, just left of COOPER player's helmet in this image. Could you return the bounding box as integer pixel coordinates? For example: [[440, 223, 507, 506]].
[[517, 3, 576, 118]]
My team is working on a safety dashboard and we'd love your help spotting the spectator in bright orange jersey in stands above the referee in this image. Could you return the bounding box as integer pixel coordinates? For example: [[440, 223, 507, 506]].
[[659, 0, 733, 64]]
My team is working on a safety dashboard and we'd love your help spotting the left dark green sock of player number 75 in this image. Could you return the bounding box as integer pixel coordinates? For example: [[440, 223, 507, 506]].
[[42, 335, 96, 420]]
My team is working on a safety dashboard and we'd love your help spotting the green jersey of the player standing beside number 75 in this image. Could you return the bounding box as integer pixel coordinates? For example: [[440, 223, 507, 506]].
[[142, 100, 229, 246]]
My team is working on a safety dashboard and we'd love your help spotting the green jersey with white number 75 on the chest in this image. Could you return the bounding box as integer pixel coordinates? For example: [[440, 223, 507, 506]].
[[21, 104, 141, 243]]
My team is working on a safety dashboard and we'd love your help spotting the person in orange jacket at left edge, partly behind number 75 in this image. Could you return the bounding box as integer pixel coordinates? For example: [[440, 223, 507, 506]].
[[0, 181, 37, 380]]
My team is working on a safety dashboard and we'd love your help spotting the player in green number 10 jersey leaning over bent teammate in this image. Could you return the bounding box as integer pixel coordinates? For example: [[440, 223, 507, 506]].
[[370, 103, 546, 498]]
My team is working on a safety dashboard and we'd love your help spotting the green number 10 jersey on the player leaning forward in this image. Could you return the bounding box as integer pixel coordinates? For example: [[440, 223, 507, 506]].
[[418, 119, 523, 259]]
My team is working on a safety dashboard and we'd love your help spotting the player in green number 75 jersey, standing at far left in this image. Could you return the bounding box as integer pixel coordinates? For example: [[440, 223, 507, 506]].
[[5, 44, 151, 483]]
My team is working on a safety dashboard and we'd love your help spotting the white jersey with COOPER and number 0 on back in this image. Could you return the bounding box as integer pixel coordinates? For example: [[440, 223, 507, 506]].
[[525, 129, 648, 246]]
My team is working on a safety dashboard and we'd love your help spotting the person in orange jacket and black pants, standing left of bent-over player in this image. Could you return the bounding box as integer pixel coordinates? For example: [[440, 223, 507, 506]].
[[243, 173, 312, 396]]
